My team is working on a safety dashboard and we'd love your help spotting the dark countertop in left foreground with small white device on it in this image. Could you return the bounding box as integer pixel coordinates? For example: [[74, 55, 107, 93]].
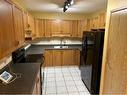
[[0, 63, 40, 94]]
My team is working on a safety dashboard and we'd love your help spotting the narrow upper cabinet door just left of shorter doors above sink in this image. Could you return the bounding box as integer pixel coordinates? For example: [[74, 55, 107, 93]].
[[45, 19, 52, 37]]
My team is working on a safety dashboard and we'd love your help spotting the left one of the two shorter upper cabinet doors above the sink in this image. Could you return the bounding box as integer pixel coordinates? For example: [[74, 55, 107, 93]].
[[51, 20, 62, 36]]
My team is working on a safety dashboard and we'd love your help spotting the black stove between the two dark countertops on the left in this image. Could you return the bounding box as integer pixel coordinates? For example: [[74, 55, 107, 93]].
[[12, 48, 45, 93]]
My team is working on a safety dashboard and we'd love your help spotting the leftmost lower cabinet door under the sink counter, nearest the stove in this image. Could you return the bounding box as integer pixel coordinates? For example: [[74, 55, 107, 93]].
[[44, 50, 53, 66]]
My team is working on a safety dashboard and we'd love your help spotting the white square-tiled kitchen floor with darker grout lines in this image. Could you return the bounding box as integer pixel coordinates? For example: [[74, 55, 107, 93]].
[[42, 66, 90, 95]]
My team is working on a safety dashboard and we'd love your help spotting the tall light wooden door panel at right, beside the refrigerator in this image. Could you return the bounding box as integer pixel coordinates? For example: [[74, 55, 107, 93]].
[[103, 9, 127, 95]]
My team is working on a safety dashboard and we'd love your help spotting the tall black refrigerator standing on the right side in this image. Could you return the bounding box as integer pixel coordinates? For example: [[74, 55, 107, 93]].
[[80, 30, 104, 94]]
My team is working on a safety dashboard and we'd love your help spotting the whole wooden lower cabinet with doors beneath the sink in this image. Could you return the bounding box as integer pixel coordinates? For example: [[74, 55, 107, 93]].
[[44, 49, 80, 67]]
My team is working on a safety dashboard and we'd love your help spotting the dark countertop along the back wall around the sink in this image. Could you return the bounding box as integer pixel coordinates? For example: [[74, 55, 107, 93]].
[[26, 44, 81, 55]]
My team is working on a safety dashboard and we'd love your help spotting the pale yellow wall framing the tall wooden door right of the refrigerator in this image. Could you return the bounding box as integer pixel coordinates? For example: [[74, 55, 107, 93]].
[[100, 0, 127, 93]]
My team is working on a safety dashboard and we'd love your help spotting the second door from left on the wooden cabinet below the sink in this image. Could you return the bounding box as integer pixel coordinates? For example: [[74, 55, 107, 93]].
[[53, 50, 62, 66]]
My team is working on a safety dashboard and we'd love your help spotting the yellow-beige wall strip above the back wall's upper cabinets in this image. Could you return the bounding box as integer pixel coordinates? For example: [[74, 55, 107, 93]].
[[30, 12, 88, 20]]
